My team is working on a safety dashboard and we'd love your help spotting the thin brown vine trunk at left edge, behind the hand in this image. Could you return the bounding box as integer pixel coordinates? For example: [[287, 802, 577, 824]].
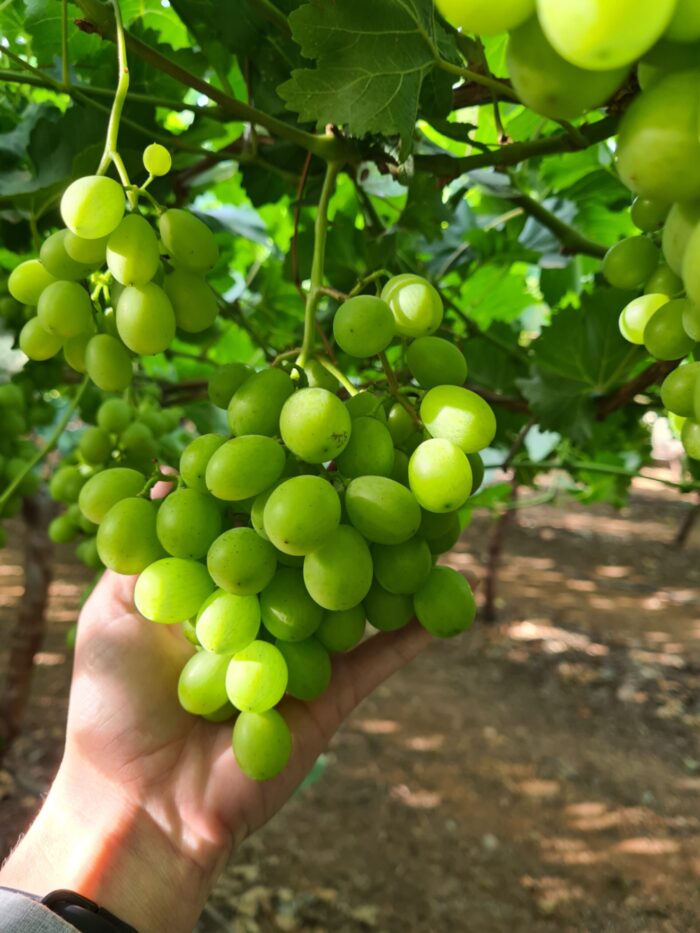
[[0, 491, 54, 762]]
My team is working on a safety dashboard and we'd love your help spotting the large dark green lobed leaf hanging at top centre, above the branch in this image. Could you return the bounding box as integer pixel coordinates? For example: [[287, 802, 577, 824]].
[[278, 0, 449, 158]]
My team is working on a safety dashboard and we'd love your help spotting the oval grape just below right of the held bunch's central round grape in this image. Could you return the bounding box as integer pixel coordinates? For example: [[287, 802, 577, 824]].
[[304, 524, 374, 612]]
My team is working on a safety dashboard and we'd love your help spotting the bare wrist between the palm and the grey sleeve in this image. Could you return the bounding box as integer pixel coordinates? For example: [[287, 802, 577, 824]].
[[0, 760, 225, 933]]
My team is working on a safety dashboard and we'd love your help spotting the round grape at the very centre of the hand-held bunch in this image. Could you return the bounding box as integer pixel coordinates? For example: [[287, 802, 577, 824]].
[[263, 476, 340, 556]]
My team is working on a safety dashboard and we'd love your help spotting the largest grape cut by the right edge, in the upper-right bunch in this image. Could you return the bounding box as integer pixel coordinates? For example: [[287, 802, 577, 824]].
[[617, 71, 700, 204]]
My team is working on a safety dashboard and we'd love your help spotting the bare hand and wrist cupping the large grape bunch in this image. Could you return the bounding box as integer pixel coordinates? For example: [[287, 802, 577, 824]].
[[0, 571, 431, 933]]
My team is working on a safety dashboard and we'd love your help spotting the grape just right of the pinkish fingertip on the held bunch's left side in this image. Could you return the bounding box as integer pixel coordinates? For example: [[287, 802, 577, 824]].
[[156, 489, 221, 560]]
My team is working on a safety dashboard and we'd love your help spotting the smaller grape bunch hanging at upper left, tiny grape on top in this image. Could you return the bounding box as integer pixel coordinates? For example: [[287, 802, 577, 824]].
[[6, 143, 218, 392]]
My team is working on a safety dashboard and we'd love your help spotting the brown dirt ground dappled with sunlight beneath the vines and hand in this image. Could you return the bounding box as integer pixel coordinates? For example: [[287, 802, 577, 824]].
[[0, 487, 700, 933]]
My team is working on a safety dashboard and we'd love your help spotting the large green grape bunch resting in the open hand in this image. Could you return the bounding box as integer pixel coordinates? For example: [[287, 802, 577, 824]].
[[78, 274, 496, 780]]
